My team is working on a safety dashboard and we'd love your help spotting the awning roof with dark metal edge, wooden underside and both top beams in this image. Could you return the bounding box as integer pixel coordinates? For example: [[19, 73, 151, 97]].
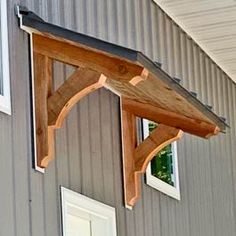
[[17, 7, 227, 138]]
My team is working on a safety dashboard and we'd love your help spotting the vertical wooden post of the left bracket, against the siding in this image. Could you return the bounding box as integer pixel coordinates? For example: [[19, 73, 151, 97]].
[[34, 52, 53, 169]]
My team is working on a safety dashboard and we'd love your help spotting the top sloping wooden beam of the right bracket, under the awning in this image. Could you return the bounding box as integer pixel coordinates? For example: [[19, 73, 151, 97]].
[[122, 98, 220, 138]]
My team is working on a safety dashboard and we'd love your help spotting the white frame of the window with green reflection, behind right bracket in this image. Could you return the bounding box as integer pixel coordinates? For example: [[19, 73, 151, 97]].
[[143, 119, 180, 200]]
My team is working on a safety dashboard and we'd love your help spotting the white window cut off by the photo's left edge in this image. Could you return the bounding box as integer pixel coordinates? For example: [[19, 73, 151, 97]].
[[0, 0, 11, 114]]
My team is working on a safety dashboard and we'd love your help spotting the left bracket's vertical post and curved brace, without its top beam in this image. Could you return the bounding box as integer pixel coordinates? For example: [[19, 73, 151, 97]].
[[34, 53, 106, 168]]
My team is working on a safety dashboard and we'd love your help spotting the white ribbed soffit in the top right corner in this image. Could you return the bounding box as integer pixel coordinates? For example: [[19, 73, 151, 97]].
[[154, 0, 236, 82]]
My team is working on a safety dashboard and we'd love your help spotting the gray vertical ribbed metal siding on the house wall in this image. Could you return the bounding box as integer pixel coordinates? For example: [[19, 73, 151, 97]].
[[0, 0, 236, 236]]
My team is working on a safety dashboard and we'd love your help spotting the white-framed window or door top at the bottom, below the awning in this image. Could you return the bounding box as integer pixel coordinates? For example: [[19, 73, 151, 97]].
[[61, 187, 116, 236]]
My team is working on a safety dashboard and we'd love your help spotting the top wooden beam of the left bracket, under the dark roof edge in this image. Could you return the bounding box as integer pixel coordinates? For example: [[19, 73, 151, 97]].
[[33, 34, 146, 83]]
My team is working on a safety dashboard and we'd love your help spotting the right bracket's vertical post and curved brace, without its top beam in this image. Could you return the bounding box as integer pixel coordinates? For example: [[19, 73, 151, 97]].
[[121, 98, 183, 208]]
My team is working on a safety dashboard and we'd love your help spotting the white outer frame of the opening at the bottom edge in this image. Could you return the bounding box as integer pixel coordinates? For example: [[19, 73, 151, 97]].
[[61, 187, 117, 236]]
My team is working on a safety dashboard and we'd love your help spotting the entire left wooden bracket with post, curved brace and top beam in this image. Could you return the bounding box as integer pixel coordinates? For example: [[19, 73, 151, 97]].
[[32, 34, 149, 170]]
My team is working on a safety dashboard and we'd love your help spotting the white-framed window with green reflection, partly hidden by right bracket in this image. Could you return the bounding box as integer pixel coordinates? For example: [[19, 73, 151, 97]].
[[143, 120, 180, 200]]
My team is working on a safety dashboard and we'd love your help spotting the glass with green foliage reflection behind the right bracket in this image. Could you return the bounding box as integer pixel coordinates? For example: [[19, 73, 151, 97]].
[[148, 122, 174, 186]]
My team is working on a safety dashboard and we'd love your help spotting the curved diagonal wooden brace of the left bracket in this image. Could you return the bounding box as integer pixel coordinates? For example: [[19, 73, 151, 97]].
[[47, 68, 106, 128]]
